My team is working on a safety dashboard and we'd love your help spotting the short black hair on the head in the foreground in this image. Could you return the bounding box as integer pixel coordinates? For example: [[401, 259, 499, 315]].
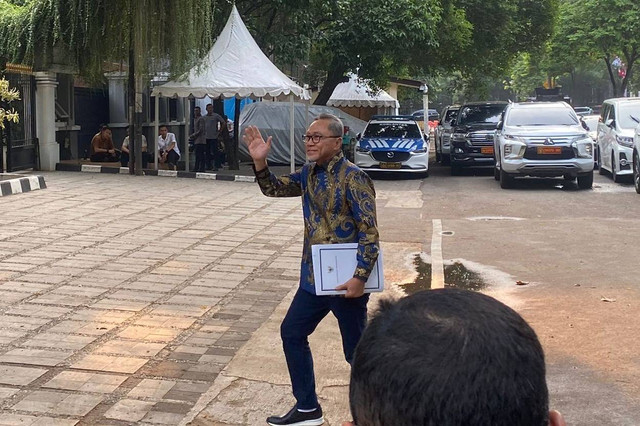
[[349, 288, 549, 426]]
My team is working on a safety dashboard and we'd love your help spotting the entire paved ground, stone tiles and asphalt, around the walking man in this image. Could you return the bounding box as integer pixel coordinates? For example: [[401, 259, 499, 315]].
[[0, 166, 640, 425]]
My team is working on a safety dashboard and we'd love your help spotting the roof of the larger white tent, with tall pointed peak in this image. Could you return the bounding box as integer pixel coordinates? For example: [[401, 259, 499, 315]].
[[152, 5, 308, 99]]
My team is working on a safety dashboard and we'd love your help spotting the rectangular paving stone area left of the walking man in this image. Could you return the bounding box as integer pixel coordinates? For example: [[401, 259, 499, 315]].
[[0, 172, 302, 426]]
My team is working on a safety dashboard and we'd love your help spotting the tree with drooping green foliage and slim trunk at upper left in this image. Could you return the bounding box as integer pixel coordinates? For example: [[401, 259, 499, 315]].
[[0, 0, 215, 174]]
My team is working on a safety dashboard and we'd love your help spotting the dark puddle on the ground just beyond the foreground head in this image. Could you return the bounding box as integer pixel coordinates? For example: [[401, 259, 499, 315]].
[[400, 254, 487, 294]]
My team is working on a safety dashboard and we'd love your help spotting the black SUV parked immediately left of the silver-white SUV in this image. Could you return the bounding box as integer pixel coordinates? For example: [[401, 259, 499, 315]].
[[451, 102, 508, 176]]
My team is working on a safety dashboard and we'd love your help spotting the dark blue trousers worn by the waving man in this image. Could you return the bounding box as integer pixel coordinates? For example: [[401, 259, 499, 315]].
[[280, 289, 369, 410]]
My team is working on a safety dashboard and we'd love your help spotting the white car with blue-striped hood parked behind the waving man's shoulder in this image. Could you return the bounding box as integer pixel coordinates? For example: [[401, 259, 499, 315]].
[[354, 116, 429, 176]]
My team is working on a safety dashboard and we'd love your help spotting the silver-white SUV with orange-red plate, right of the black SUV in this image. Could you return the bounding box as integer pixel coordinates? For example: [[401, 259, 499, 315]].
[[494, 102, 594, 189]]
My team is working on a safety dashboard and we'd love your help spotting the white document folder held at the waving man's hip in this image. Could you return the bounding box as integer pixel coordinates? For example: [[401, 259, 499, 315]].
[[311, 243, 384, 296]]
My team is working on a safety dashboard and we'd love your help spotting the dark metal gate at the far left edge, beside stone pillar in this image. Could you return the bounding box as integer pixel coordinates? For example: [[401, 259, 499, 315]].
[[0, 64, 40, 172]]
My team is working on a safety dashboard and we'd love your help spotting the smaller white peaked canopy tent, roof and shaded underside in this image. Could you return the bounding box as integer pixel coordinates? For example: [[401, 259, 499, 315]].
[[327, 74, 400, 121]]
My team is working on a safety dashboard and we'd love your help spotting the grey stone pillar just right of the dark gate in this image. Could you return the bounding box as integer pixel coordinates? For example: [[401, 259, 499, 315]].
[[35, 71, 60, 170]]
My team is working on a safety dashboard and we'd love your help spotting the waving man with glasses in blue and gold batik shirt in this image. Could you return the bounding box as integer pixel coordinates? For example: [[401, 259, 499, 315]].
[[243, 114, 380, 425]]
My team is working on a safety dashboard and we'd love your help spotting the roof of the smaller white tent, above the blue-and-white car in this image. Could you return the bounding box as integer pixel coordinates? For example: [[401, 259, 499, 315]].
[[327, 74, 400, 108]]
